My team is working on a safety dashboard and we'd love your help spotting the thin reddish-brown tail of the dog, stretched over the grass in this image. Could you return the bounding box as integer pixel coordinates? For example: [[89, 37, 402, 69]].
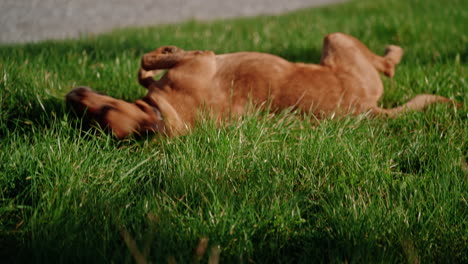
[[374, 94, 462, 117]]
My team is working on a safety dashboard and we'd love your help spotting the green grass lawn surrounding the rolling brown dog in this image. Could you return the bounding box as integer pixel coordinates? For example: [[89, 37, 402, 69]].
[[0, 0, 468, 263]]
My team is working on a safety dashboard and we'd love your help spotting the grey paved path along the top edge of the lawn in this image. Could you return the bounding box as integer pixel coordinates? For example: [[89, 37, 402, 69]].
[[0, 0, 343, 43]]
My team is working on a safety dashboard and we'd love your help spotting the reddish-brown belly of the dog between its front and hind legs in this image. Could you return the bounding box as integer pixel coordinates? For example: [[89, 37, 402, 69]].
[[215, 52, 344, 114]]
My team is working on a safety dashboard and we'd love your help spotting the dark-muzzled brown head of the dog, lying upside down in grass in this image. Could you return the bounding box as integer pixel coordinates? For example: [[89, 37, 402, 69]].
[[66, 87, 165, 139]]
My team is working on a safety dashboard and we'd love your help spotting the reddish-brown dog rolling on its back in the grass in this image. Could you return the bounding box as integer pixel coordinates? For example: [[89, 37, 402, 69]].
[[66, 33, 452, 138]]
